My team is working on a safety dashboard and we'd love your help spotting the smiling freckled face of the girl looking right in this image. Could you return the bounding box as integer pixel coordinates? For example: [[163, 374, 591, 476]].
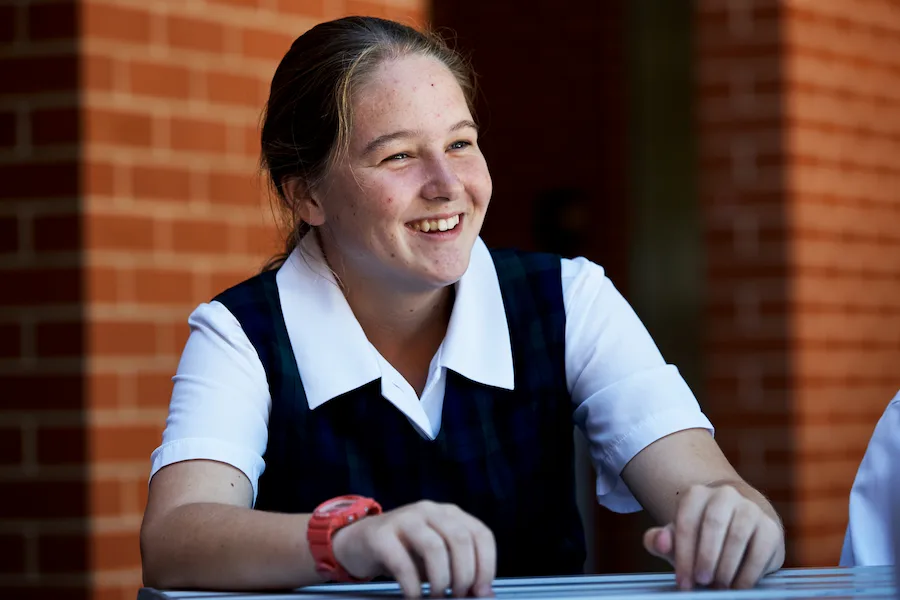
[[310, 56, 492, 291]]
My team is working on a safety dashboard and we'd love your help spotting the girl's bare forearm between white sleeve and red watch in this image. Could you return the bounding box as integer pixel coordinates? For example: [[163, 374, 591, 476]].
[[141, 503, 322, 590]]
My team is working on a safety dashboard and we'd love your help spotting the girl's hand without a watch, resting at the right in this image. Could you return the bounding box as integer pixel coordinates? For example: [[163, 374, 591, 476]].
[[644, 485, 784, 589]]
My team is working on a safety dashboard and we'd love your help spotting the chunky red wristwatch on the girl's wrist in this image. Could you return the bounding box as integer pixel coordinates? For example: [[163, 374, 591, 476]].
[[306, 496, 381, 583]]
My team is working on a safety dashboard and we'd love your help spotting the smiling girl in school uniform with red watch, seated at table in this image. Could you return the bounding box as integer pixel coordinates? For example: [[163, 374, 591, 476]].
[[141, 17, 784, 596]]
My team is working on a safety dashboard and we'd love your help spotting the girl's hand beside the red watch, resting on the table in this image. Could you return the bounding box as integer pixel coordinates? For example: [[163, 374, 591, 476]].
[[333, 501, 497, 598]]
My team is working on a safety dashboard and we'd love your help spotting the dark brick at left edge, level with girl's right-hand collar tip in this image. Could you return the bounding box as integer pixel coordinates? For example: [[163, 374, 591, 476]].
[[0, 372, 84, 413]]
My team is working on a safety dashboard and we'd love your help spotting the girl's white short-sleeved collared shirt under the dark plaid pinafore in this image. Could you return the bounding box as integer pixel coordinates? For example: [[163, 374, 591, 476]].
[[156, 236, 712, 512]]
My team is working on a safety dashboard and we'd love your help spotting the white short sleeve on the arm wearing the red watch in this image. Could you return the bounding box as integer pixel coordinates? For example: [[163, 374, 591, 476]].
[[150, 302, 272, 504]]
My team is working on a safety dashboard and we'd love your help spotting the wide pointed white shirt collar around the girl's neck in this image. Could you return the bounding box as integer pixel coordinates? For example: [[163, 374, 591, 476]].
[[276, 234, 514, 409]]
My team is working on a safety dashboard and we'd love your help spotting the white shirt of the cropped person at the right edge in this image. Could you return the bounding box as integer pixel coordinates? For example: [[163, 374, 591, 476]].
[[841, 392, 900, 567]]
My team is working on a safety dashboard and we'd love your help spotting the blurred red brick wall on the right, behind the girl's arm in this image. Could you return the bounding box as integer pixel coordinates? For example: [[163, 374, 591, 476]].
[[697, 0, 900, 565]]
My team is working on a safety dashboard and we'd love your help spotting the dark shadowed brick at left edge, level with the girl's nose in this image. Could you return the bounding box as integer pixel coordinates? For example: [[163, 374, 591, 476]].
[[0, 162, 79, 201]]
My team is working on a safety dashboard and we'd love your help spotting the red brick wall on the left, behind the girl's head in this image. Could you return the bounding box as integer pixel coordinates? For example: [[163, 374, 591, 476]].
[[0, 0, 424, 600]]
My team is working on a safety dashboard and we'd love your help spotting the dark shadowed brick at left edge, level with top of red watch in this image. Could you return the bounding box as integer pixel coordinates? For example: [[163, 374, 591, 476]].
[[0, 480, 87, 519]]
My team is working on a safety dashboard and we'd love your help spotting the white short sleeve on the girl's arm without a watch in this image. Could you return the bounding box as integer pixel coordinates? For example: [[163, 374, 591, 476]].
[[562, 258, 713, 512]]
